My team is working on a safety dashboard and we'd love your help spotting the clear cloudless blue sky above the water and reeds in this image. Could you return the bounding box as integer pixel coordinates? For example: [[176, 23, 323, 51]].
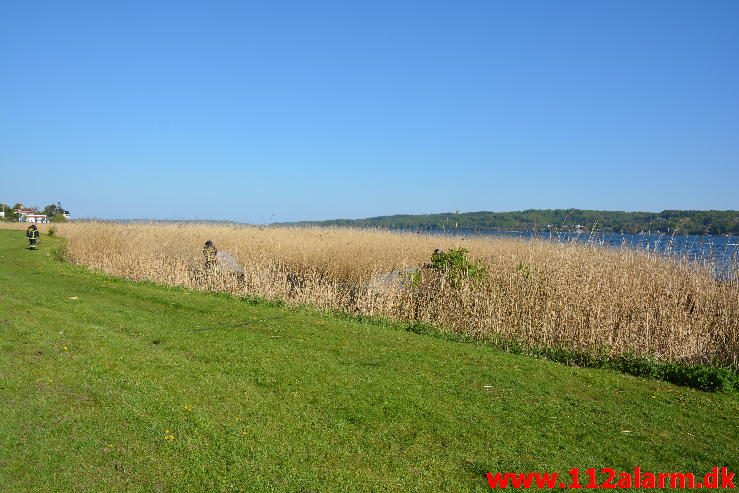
[[0, 0, 739, 222]]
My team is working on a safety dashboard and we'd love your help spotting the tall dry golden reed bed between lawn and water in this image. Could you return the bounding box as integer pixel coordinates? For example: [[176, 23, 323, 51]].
[[7, 223, 739, 369]]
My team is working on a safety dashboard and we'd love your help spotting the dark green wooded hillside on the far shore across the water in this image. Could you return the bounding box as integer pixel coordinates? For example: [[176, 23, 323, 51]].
[[289, 209, 739, 235]]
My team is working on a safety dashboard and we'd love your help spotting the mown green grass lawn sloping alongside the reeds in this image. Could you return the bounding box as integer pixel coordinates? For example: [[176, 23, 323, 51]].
[[0, 231, 739, 493]]
